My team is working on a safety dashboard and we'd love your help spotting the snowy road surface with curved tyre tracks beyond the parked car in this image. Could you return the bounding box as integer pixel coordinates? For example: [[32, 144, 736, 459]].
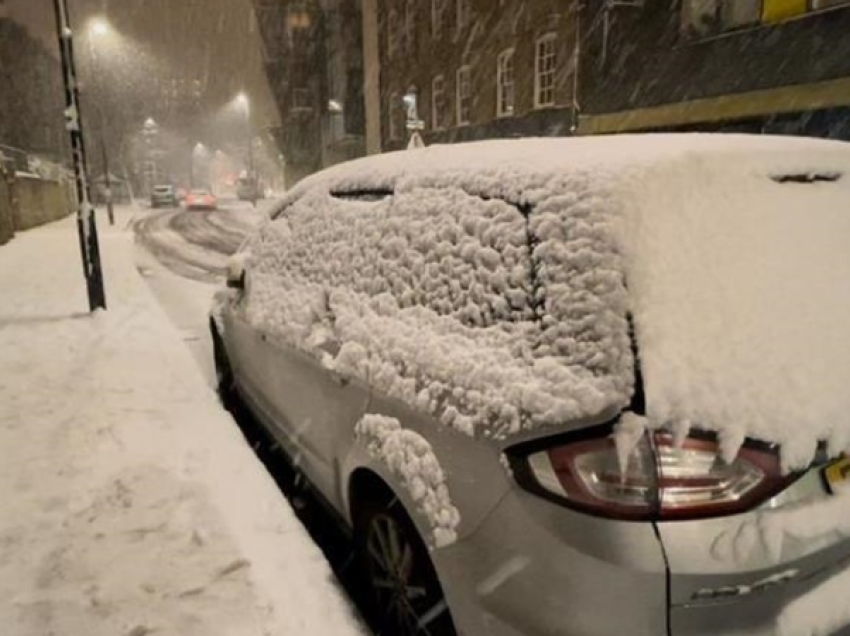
[[134, 201, 272, 283]]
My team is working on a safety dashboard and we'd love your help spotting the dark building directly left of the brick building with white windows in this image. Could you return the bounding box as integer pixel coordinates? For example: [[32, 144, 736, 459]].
[[254, 0, 365, 185]]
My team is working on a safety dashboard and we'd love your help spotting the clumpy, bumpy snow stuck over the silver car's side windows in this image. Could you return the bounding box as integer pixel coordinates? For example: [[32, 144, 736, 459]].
[[246, 179, 632, 438]]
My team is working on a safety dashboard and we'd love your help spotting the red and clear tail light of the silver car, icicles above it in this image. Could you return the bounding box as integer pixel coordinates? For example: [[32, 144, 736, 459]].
[[528, 431, 798, 520]]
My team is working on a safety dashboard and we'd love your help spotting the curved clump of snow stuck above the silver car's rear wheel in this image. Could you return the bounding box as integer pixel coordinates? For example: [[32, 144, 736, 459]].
[[355, 414, 460, 548]]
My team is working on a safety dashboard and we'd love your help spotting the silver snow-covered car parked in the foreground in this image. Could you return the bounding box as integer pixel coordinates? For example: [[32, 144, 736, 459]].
[[211, 135, 850, 636]]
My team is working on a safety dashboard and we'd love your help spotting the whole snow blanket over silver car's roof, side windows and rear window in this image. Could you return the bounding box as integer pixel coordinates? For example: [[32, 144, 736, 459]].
[[248, 135, 850, 469]]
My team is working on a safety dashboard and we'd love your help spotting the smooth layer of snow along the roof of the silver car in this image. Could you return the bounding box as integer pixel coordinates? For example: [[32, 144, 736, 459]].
[[284, 133, 847, 205]]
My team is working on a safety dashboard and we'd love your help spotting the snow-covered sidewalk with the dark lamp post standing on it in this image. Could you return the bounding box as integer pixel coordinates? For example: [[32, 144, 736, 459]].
[[0, 211, 363, 636]]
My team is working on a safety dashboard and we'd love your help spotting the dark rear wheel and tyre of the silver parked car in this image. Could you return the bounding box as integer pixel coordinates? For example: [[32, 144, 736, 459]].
[[354, 497, 457, 636]]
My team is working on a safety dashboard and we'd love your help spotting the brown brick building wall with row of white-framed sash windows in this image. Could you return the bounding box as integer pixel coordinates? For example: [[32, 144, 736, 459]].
[[377, 0, 580, 150]]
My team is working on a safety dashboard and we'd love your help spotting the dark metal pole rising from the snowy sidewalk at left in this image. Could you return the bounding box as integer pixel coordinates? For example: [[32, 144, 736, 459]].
[[53, 0, 106, 311]]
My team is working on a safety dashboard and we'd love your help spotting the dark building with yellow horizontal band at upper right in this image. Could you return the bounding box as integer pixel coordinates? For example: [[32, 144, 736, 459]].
[[579, 0, 850, 139]]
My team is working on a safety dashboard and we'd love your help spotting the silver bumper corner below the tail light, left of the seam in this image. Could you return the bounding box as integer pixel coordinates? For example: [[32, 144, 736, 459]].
[[434, 488, 667, 636]]
